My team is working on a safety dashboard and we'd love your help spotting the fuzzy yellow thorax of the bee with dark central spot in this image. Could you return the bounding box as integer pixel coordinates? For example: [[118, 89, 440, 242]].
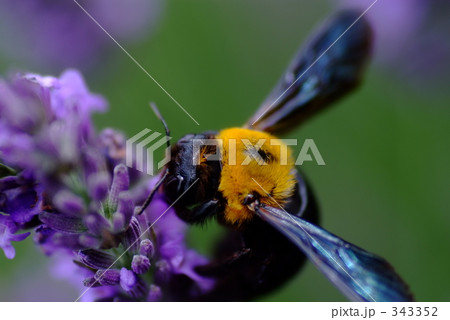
[[217, 128, 295, 226]]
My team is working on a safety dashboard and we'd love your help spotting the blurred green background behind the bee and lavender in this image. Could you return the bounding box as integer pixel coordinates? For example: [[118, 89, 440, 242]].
[[0, 0, 450, 301]]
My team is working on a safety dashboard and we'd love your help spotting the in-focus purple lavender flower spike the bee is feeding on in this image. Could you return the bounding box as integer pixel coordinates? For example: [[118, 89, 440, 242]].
[[0, 70, 214, 301]]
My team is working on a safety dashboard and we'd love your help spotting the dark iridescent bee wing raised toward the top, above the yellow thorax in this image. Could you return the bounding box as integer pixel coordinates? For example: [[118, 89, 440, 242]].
[[246, 11, 372, 134]]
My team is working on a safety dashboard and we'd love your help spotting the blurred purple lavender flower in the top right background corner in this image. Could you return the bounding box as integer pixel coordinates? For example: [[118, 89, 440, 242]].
[[339, 0, 450, 85]]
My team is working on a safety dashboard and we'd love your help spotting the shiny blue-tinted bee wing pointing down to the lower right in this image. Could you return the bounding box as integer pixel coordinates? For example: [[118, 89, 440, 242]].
[[255, 205, 413, 301]]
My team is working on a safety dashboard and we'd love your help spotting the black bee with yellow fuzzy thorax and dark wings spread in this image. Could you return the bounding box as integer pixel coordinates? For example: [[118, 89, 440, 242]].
[[141, 11, 413, 301]]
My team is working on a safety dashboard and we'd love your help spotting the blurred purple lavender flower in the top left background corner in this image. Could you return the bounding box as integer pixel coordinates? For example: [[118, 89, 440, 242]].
[[0, 0, 161, 70]]
